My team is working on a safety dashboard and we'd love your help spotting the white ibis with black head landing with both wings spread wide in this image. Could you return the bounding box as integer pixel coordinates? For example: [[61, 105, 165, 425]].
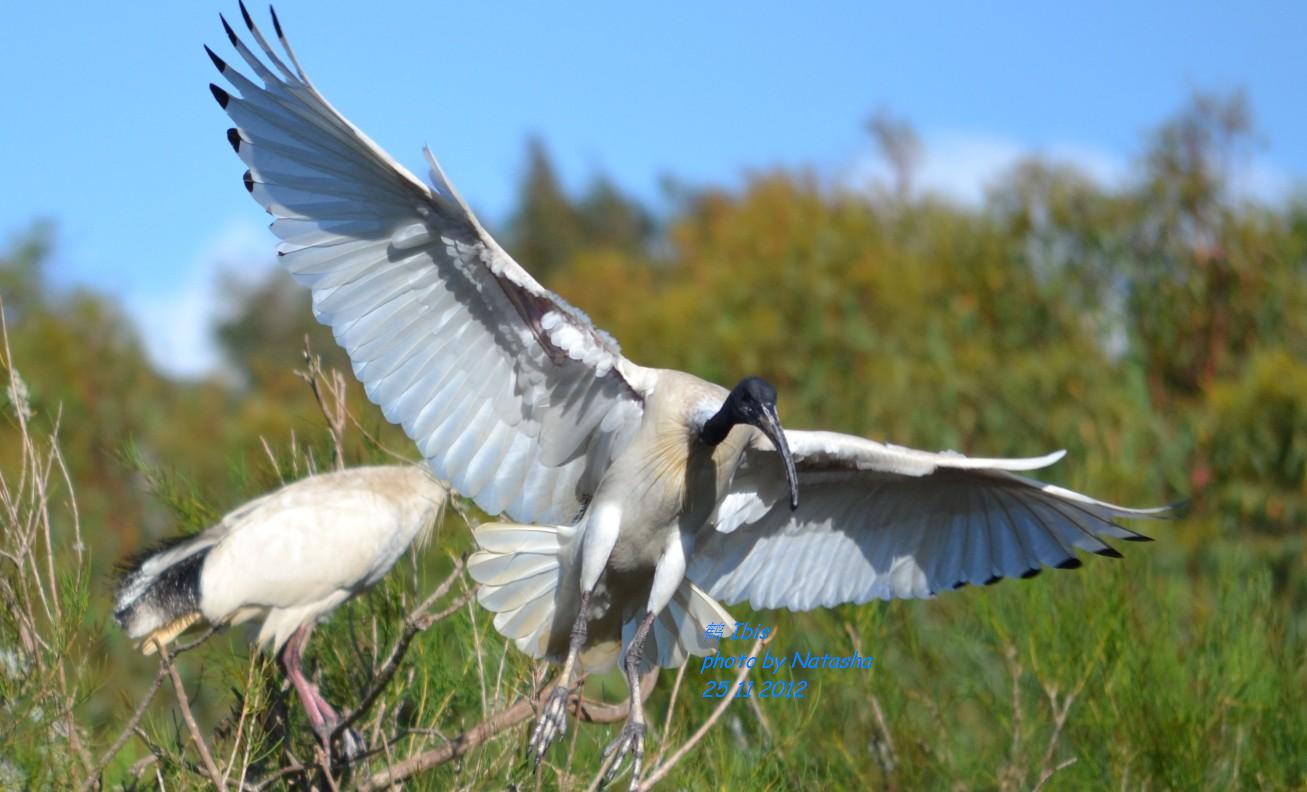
[[209, 5, 1162, 784]]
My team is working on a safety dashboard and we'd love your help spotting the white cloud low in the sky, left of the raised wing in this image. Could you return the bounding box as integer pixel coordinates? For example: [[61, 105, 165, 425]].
[[125, 215, 273, 379]]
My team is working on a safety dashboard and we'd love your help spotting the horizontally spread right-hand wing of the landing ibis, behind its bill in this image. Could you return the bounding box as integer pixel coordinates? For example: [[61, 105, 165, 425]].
[[686, 431, 1168, 610]]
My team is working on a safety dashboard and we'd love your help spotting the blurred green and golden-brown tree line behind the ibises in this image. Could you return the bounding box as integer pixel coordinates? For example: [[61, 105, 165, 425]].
[[0, 94, 1307, 785]]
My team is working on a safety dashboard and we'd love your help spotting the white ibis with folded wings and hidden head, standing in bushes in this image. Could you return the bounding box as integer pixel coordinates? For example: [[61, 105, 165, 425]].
[[114, 465, 447, 754]]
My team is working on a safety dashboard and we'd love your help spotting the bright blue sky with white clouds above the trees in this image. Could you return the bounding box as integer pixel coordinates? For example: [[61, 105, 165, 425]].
[[0, 0, 1307, 374]]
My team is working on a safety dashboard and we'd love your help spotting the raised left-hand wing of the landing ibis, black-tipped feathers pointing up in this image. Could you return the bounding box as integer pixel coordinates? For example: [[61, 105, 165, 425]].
[[209, 5, 652, 524]]
